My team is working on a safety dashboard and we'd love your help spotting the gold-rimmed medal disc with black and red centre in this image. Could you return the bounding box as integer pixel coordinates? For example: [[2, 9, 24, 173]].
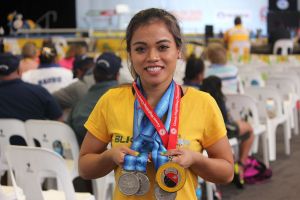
[[155, 162, 186, 192]]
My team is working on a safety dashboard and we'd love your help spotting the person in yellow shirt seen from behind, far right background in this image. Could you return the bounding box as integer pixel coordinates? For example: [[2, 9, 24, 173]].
[[223, 16, 250, 49]]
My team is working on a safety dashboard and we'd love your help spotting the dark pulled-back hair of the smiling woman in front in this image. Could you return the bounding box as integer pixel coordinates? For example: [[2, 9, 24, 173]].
[[125, 8, 183, 78]]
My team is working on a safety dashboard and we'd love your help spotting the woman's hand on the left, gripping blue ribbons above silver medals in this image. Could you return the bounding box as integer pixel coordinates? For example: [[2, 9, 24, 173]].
[[109, 146, 139, 166]]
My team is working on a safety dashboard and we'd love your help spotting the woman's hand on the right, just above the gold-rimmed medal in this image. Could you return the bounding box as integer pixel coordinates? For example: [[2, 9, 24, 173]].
[[164, 148, 197, 168]]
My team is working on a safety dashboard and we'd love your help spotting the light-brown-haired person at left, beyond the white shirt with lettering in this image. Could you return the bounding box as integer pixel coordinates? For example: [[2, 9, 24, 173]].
[[19, 42, 39, 74]]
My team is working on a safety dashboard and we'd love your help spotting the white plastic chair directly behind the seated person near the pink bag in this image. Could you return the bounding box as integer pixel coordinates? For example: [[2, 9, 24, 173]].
[[226, 94, 269, 167]]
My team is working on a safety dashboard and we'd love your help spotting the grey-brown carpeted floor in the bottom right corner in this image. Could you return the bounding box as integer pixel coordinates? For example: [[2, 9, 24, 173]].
[[220, 127, 300, 200]]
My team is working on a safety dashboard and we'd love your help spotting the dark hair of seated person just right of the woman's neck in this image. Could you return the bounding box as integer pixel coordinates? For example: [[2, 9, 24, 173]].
[[183, 54, 204, 82]]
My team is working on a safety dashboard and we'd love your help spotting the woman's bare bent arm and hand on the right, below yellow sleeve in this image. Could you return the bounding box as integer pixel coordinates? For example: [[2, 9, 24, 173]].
[[166, 137, 234, 183]]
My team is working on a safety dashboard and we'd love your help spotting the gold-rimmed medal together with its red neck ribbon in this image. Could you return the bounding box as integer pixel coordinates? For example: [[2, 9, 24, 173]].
[[136, 81, 186, 199]]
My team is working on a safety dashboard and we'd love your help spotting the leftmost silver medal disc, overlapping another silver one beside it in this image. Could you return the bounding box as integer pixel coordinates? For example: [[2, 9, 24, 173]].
[[118, 172, 140, 195]]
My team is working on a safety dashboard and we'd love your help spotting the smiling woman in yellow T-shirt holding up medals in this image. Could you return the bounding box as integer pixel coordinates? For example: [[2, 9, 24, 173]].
[[79, 8, 233, 200]]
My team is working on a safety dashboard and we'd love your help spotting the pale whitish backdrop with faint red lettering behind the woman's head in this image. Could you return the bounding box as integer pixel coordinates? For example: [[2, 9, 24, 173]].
[[76, 0, 268, 33]]
